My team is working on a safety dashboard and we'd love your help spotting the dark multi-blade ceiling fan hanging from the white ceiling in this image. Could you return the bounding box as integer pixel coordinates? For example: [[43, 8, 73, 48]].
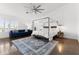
[[26, 5, 45, 14]]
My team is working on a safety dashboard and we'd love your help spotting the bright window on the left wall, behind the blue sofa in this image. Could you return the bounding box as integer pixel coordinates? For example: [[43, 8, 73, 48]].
[[0, 18, 17, 32]]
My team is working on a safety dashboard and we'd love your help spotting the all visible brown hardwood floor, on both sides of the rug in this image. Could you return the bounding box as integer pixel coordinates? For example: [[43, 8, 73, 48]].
[[0, 38, 79, 55]]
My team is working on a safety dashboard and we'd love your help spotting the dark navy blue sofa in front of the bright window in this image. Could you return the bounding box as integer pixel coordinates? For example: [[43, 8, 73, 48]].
[[9, 29, 32, 39]]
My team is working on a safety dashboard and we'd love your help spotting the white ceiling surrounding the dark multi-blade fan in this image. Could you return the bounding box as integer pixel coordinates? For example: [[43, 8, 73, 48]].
[[0, 3, 65, 18]]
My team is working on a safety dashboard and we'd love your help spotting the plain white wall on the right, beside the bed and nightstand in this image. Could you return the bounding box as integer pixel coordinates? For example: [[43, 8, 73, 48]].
[[46, 4, 79, 39]]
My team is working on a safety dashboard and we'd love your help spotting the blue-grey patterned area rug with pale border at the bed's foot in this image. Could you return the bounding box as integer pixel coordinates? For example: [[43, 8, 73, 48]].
[[12, 37, 57, 55]]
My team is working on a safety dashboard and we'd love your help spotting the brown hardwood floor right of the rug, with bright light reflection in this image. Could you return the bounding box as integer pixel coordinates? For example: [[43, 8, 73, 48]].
[[51, 39, 79, 55]]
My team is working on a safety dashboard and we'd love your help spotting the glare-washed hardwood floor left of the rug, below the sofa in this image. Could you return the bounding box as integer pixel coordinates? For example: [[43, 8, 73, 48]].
[[0, 39, 20, 55]]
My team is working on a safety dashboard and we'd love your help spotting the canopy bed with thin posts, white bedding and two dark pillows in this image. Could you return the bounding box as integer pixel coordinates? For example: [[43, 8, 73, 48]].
[[32, 17, 58, 41]]
